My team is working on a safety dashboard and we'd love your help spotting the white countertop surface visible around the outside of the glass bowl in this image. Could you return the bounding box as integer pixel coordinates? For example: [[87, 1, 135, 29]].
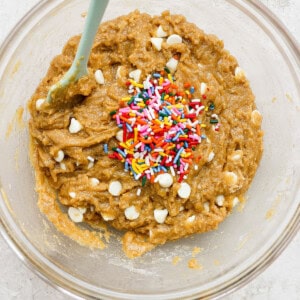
[[0, 0, 300, 300]]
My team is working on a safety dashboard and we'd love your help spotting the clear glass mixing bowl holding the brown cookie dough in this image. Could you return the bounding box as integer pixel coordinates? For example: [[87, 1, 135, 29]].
[[0, 0, 300, 299]]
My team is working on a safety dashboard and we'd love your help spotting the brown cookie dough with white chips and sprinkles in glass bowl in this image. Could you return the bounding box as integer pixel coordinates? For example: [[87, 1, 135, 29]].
[[29, 11, 263, 258]]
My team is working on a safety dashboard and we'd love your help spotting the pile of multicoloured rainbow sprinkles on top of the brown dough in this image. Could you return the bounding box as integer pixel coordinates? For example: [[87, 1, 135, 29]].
[[105, 68, 220, 186]]
